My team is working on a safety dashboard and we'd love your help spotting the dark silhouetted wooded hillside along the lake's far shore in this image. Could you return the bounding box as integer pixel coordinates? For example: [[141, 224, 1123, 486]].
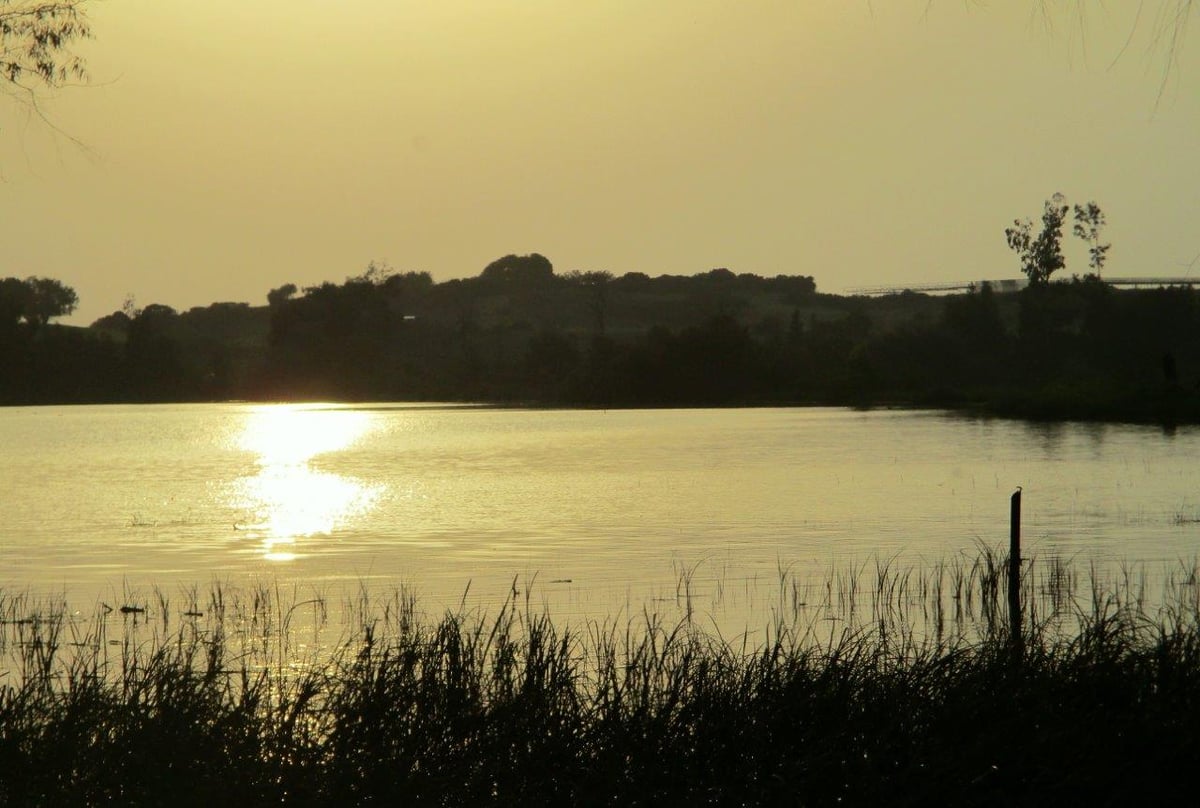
[[0, 253, 1200, 420]]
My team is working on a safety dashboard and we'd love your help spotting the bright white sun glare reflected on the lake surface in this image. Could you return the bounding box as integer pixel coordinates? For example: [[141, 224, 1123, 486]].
[[236, 405, 379, 562]]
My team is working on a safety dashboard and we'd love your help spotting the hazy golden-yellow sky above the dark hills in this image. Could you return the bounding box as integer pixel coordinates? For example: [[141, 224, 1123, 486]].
[[0, 0, 1200, 323]]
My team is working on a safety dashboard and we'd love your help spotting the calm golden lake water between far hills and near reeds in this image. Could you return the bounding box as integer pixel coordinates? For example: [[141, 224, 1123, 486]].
[[0, 403, 1200, 622]]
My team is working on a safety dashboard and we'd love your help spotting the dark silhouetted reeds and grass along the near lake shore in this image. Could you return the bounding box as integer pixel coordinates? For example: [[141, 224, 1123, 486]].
[[0, 559, 1200, 806]]
